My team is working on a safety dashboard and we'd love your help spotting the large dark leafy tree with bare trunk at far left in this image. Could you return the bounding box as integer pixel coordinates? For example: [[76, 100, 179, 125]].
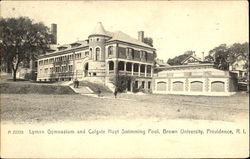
[[0, 17, 51, 81]]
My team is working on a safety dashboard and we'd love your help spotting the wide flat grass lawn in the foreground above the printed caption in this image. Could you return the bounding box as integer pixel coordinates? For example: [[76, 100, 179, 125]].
[[1, 93, 249, 123]]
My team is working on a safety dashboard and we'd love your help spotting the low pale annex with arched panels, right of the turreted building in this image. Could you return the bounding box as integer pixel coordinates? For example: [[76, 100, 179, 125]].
[[153, 55, 237, 96]]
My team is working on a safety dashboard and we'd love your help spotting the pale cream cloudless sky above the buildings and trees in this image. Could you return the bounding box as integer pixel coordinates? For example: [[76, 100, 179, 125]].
[[1, 1, 249, 61]]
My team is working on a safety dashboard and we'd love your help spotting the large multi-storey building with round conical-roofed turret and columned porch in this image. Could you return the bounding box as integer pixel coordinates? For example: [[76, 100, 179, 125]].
[[37, 22, 156, 91]]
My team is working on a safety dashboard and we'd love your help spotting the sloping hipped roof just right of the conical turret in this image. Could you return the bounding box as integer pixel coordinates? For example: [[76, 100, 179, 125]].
[[108, 31, 153, 48]]
